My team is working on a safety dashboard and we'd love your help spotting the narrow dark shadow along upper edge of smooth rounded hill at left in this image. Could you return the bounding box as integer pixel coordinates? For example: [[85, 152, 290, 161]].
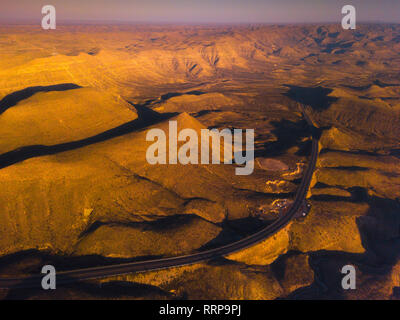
[[0, 83, 82, 114]]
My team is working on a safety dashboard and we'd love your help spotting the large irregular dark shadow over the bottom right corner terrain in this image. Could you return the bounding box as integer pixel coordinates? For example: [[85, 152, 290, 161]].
[[282, 187, 400, 299]]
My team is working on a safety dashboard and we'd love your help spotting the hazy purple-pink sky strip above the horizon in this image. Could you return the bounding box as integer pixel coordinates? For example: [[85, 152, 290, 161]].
[[0, 0, 400, 23]]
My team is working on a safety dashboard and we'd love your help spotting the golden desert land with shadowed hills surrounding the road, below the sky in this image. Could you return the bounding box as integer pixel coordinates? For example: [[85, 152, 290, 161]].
[[0, 24, 400, 299]]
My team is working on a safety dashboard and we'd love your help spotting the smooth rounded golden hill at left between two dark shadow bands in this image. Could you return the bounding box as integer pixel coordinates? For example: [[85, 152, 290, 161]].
[[0, 88, 137, 153]]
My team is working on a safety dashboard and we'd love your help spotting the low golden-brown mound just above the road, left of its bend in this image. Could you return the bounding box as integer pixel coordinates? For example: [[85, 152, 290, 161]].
[[74, 216, 221, 258]]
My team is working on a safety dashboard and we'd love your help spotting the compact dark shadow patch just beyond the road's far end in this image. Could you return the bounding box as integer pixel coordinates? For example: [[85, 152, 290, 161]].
[[284, 85, 338, 110]]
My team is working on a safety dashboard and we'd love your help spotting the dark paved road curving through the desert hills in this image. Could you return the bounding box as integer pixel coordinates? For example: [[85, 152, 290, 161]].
[[0, 105, 318, 288]]
